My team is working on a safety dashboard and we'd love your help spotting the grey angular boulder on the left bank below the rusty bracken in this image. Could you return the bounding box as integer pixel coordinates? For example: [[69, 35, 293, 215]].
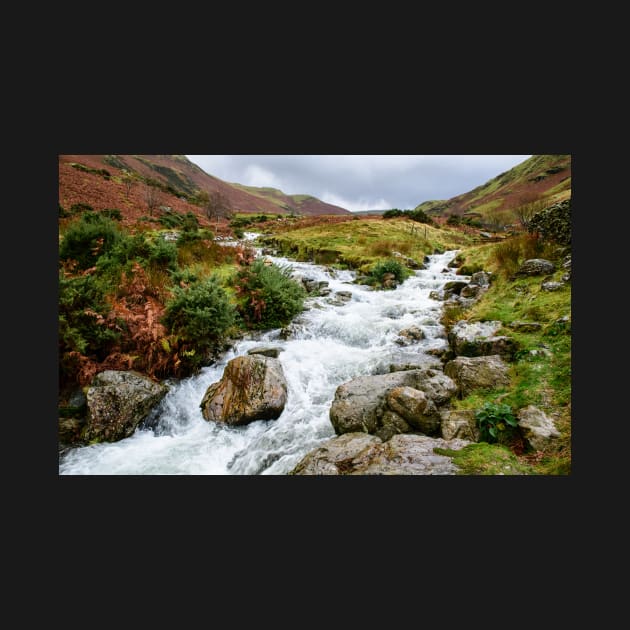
[[81, 370, 168, 442]]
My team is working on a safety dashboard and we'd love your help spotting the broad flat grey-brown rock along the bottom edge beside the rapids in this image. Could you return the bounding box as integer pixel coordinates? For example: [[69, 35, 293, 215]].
[[291, 433, 470, 475]]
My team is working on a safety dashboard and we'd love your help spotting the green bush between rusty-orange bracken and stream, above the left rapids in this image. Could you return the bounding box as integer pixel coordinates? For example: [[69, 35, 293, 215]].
[[162, 276, 236, 367]]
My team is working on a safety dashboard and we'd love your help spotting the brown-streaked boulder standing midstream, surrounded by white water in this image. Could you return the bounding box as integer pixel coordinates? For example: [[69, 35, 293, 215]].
[[200, 354, 287, 425]]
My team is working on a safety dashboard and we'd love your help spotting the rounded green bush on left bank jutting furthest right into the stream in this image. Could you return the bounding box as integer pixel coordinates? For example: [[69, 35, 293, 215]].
[[236, 260, 306, 328]]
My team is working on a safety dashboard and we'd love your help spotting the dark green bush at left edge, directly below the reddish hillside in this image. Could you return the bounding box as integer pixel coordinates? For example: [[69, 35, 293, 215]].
[[59, 213, 122, 269]]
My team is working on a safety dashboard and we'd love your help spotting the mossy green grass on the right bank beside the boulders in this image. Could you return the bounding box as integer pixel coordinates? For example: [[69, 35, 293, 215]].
[[443, 243, 571, 474]]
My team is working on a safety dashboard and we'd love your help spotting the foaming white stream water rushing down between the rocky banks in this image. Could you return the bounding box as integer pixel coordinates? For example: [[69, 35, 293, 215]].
[[59, 244, 466, 475]]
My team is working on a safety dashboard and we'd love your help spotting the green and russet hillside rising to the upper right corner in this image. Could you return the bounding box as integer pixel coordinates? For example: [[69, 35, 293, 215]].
[[416, 155, 571, 222]]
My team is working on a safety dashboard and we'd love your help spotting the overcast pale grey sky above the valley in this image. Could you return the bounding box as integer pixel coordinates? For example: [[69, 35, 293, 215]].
[[186, 155, 531, 212]]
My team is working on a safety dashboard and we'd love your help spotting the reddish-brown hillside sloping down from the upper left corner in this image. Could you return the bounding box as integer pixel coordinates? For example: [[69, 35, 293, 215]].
[[59, 155, 350, 224]]
